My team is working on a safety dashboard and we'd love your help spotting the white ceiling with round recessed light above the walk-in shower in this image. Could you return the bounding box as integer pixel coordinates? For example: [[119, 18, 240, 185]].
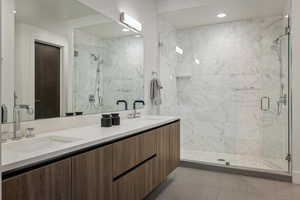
[[156, 0, 290, 29]]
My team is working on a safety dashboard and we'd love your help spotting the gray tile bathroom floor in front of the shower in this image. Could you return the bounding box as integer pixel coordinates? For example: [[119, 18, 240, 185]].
[[146, 167, 300, 200]]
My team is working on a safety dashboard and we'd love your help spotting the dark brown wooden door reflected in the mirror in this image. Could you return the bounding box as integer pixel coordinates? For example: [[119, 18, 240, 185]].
[[35, 42, 60, 119]]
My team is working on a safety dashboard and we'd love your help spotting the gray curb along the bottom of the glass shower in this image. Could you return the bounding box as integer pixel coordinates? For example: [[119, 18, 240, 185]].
[[180, 160, 292, 183]]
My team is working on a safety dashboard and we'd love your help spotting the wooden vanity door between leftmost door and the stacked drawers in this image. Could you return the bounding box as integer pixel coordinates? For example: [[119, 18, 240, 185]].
[[72, 145, 113, 200]]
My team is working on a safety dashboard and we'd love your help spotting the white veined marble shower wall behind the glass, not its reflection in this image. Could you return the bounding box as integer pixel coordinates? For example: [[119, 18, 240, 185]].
[[160, 17, 288, 162]]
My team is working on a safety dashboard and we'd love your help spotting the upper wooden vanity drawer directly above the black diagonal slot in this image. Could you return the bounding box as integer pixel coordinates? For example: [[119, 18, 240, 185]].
[[113, 130, 156, 177]]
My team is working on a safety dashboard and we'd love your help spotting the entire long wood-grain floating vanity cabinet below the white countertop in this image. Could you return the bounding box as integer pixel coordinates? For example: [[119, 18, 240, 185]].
[[2, 121, 180, 200]]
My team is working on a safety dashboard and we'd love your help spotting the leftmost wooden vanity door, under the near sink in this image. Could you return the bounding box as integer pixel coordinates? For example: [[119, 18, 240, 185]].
[[3, 159, 71, 200]]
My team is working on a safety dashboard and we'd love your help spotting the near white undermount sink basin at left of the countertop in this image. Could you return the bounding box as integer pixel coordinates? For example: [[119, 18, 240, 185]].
[[2, 136, 81, 153]]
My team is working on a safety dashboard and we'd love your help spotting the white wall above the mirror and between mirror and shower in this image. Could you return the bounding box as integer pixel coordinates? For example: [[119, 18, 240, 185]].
[[78, 0, 158, 113]]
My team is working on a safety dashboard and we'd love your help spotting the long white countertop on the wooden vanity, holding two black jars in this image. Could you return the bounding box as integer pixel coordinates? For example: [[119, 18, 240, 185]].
[[2, 116, 179, 172]]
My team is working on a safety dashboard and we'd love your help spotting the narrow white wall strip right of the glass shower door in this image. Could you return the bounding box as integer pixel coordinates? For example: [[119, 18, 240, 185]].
[[292, 0, 300, 184]]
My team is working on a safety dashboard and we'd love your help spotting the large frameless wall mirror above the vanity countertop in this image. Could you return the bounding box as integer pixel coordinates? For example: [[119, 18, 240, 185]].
[[1, 0, 144, 123]]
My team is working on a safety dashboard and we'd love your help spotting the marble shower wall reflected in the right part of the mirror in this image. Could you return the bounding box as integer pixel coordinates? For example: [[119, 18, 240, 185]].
[[73, 30, 144, 113]]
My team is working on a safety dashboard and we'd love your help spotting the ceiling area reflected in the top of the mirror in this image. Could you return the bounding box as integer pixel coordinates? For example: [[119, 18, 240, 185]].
[[15, 0, 136, 38]]
